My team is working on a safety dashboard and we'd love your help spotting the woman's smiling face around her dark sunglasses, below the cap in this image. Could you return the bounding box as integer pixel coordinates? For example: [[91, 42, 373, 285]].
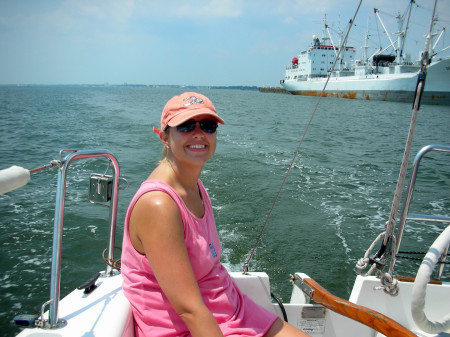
[[162, 116, 217, 165]]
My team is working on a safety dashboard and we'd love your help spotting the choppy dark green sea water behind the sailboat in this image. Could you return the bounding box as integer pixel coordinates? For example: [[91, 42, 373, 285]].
[[0, 86, 450, 336]]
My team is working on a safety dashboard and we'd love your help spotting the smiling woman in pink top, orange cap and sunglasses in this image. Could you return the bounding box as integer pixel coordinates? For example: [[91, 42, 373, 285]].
[[122, 92, 304, 337]]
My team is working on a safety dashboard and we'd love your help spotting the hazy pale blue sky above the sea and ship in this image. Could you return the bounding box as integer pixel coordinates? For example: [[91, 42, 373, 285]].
[[0, 0, 450, 86]]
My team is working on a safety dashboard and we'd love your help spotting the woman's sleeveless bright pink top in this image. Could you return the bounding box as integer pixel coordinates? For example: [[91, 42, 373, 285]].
[[121, 180, 277, 337]]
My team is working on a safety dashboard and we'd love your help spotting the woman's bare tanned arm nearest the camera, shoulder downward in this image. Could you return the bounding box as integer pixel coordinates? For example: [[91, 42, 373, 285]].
[[130, 192, 223, 337]]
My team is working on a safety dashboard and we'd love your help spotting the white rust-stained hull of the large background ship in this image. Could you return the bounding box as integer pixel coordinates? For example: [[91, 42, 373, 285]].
[[281, 58, 450, 105]]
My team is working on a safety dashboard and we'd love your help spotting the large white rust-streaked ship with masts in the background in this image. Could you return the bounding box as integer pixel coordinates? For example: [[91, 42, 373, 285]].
[[280, 2, 450, 105]]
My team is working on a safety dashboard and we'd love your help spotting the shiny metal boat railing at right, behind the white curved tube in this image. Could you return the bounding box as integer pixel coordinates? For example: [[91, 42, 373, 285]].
[[391, 144, 450, 280]]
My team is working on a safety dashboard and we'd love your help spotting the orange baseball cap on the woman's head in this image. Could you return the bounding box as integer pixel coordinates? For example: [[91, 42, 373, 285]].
[[153, 92, 225, 136]]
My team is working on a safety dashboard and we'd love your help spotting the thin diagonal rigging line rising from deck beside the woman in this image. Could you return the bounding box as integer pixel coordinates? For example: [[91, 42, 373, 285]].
[[242, 0, 362, 274]]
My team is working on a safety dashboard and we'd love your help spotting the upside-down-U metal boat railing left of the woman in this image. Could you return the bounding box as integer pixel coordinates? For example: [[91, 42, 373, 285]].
[[41, 150, 119, 329]]
